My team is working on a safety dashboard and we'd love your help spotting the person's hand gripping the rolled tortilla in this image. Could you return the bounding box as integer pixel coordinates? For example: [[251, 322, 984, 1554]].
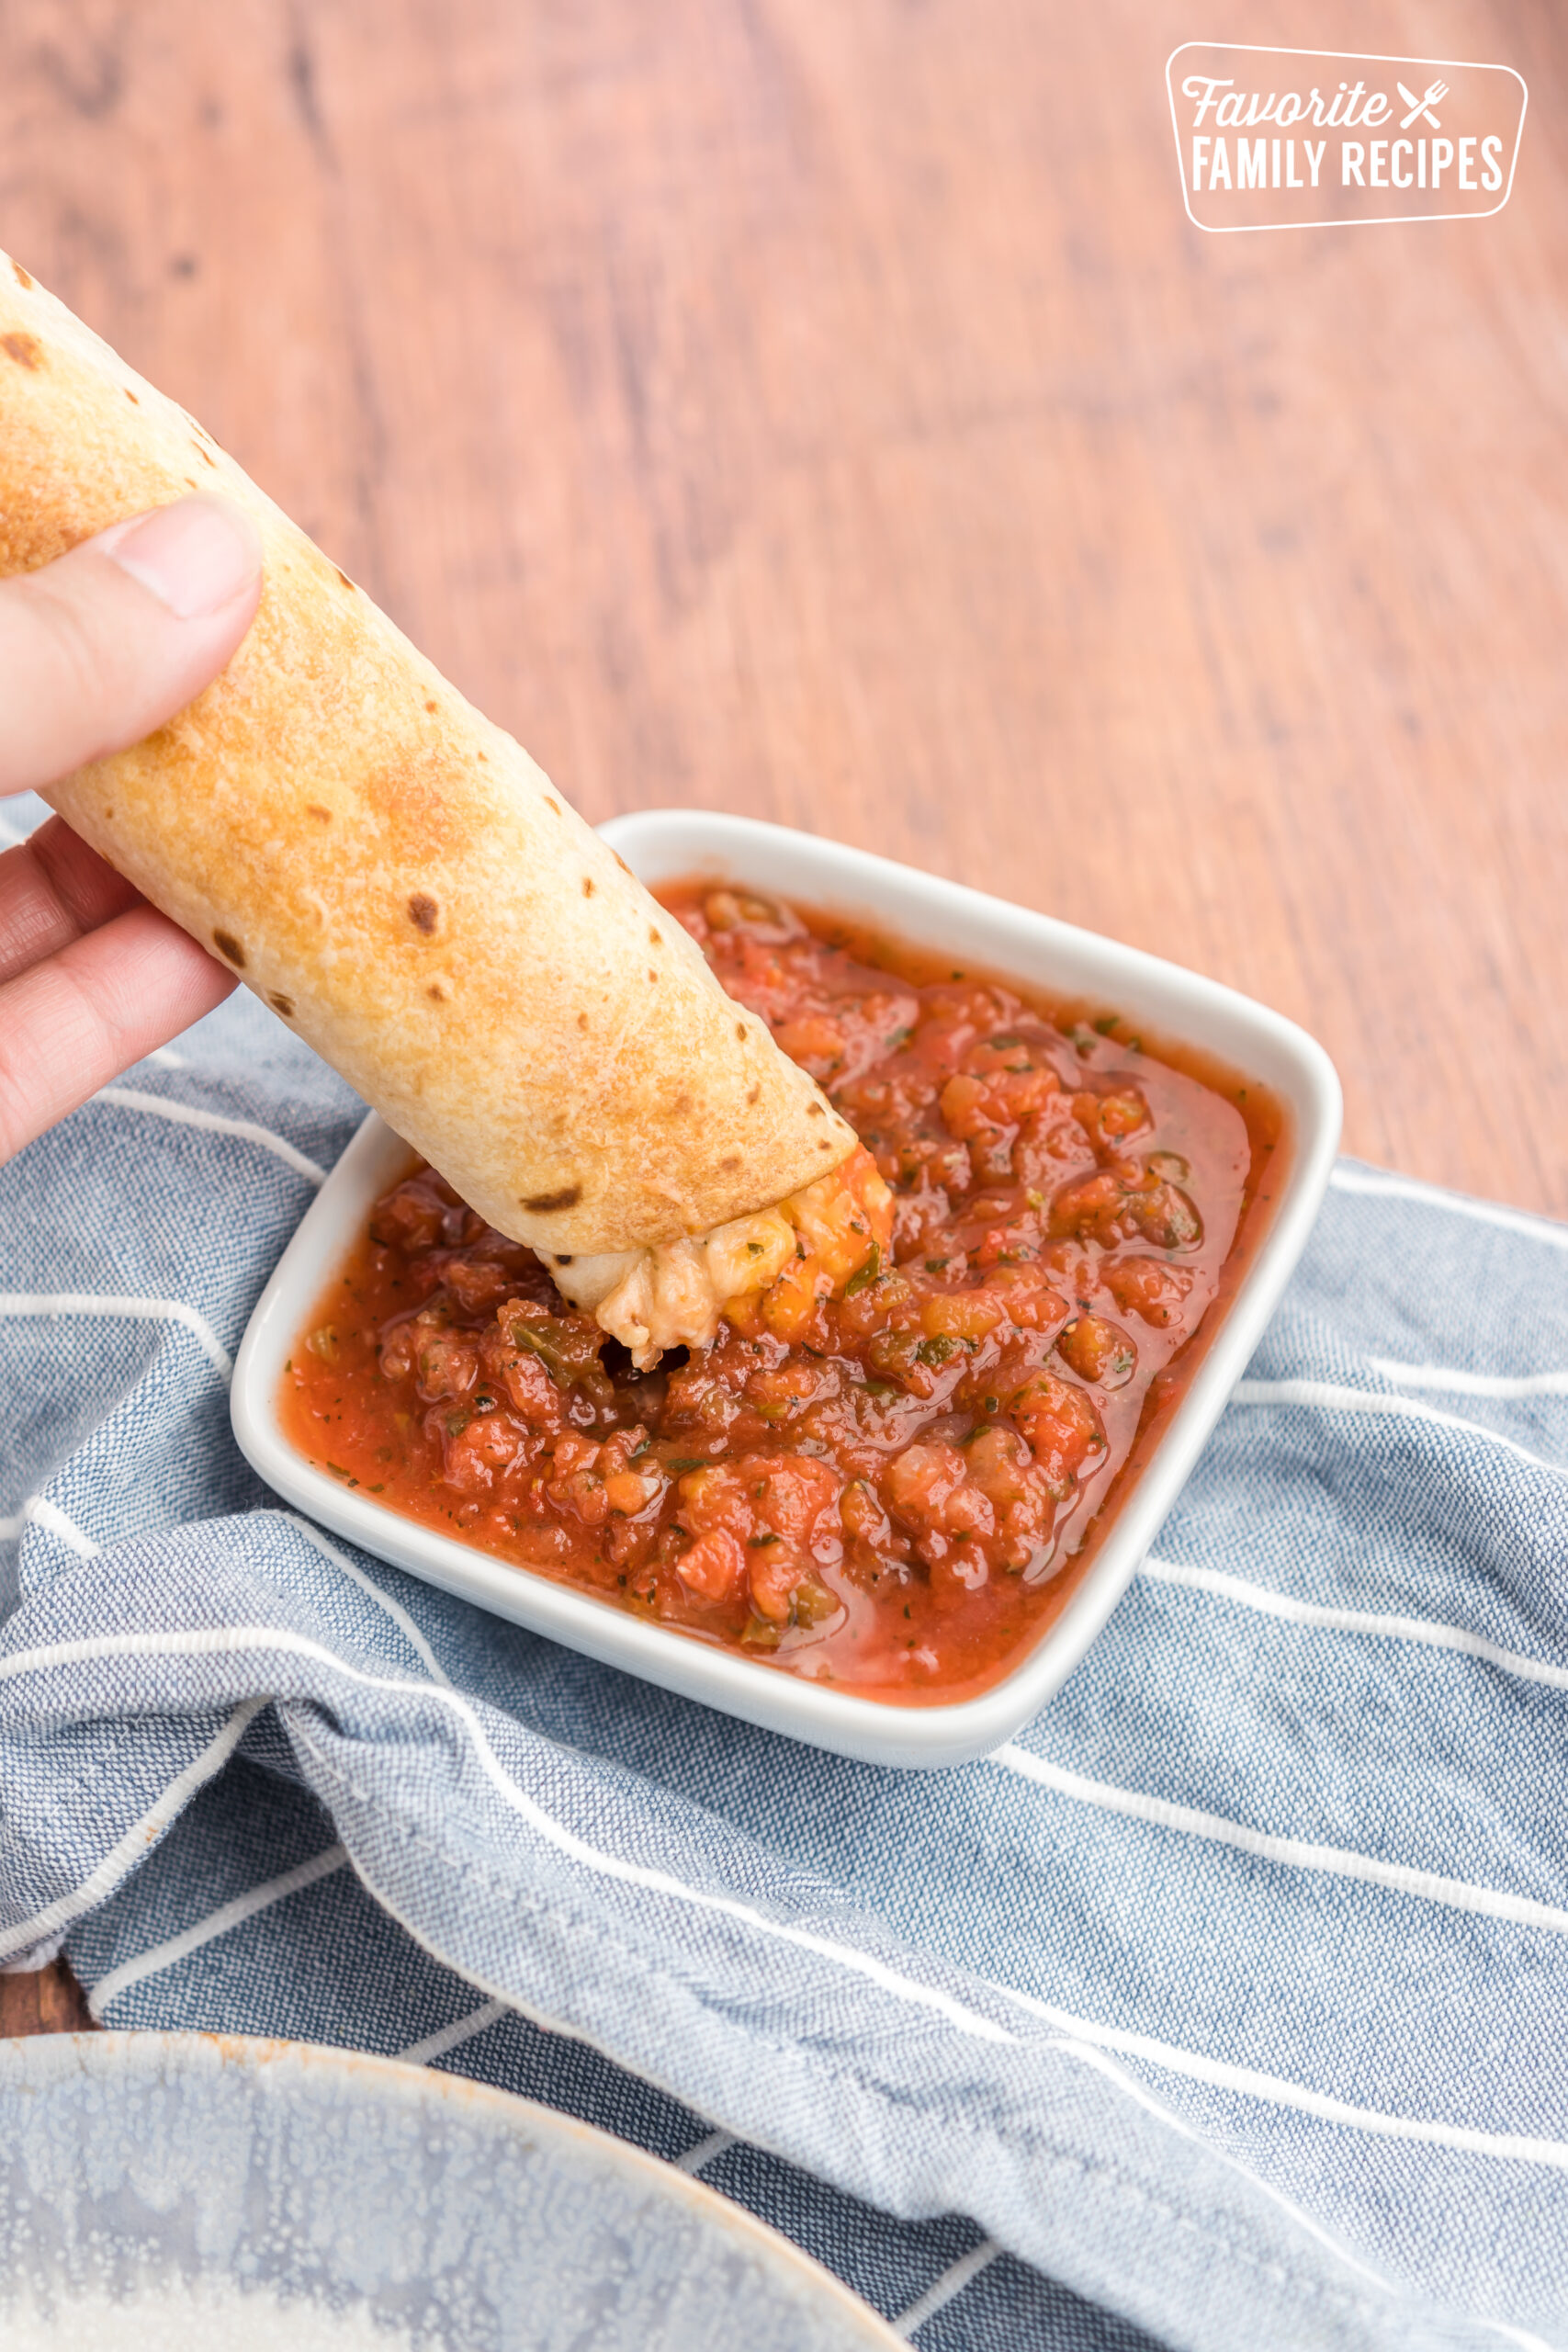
[[0, 499, 261, 1162]]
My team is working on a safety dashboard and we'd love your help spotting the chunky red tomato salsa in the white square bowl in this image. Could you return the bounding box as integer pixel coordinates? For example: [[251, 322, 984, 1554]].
[[282, 885, 1279, 1702]]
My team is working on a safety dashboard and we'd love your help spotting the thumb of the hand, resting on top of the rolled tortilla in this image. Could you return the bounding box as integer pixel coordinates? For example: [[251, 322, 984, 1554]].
[[0, 499, 261, 793]]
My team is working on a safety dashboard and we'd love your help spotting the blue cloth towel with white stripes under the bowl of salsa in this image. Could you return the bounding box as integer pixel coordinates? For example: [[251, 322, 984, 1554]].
[[0, 795, 1568, 2352]]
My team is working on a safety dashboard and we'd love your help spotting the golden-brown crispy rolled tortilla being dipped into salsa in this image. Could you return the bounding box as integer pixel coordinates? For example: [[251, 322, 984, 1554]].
[[0, 256, 856, 1298]]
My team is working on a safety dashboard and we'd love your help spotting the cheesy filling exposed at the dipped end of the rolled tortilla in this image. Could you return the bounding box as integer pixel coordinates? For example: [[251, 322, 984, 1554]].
[[541, 1146, 894, 1371]]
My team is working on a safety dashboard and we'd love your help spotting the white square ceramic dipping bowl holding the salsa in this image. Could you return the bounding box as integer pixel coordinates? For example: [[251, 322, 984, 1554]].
[[232, 809, 1340, 1767]]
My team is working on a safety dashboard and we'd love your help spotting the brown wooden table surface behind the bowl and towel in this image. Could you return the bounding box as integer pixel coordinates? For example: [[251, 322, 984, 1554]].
[[0, 0, 1568, 2023]]
